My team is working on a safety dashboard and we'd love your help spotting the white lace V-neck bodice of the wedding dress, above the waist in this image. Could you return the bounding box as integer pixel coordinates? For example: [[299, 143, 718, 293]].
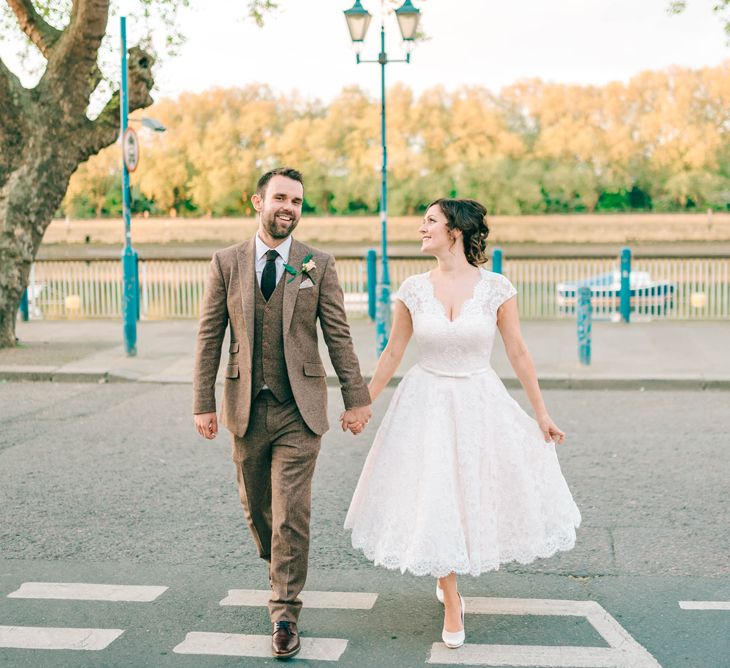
[[396, 269, 517, 375]]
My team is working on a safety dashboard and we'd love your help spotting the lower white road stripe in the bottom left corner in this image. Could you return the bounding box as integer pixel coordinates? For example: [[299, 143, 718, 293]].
[[0, 626, 124, 650]]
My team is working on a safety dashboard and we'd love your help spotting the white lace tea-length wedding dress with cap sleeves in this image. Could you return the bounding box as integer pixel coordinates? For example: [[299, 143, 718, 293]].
[[345, 269, 581, 577]]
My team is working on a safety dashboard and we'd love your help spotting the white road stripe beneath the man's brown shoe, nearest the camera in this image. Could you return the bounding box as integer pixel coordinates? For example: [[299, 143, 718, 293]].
[[172, 632, 347, 661]]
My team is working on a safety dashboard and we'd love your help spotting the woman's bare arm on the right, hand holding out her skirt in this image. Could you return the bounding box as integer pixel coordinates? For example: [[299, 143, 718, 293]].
[[497, 298, 565, 443]]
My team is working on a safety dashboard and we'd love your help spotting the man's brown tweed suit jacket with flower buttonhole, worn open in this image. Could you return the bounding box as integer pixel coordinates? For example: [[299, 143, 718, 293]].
[[193, 238, 370, 436]]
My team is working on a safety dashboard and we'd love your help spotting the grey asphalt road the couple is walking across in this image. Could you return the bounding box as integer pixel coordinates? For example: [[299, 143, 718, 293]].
[[0, 383, 730, 668]]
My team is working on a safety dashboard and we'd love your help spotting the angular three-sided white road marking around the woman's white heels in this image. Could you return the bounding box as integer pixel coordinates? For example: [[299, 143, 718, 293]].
[[428, 597, 661, 668]]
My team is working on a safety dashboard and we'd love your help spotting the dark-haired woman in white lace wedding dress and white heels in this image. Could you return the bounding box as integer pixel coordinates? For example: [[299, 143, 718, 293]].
[[342, 199, 581, 648]]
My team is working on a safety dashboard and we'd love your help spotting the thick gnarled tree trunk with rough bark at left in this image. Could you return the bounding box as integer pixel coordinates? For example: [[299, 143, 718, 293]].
[[0, 0, 154, 348]]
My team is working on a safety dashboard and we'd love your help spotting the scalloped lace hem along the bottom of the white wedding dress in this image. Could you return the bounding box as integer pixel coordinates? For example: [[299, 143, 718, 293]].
[[352, 523, 580, 578]]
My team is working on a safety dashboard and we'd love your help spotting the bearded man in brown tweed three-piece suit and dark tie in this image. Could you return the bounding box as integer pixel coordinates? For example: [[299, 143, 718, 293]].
[[193, 168, 371, 659]]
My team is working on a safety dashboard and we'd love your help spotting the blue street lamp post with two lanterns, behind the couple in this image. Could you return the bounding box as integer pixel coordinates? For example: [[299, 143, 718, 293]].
[[344, 0, 421, 355]]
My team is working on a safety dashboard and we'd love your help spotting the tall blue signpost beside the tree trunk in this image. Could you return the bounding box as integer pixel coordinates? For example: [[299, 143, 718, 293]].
[[120, 16, 139, 357]]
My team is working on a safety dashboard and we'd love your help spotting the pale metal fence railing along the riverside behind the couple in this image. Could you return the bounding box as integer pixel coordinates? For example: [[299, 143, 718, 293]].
[[21, 257, 730, 320]]
